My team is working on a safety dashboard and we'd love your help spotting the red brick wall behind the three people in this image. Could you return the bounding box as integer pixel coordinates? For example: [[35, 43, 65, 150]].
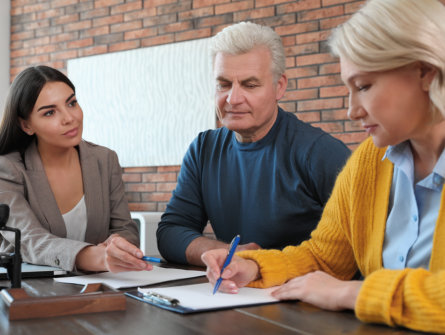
[[8, 0, 392, 211]]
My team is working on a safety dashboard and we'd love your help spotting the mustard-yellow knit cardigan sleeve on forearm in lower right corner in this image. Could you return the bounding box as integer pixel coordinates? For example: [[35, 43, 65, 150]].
[[355, 269, 445, 333]]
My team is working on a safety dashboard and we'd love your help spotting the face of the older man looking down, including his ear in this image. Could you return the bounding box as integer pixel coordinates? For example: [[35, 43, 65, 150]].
[[213, 48, 287, 142]]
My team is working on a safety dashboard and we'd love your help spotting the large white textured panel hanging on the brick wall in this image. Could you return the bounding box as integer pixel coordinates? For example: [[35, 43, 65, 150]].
[[68, 39, 215, 167]]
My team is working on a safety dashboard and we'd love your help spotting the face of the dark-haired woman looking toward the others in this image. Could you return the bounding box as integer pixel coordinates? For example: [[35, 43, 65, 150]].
[[20, 82, 83, 149]]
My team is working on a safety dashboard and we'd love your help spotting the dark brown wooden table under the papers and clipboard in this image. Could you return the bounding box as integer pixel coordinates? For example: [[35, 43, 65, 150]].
[[0, 270, 422, 335]]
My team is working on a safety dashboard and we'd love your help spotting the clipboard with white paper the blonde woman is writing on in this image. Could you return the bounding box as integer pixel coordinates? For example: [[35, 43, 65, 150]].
[[126, 283, 279, 313]]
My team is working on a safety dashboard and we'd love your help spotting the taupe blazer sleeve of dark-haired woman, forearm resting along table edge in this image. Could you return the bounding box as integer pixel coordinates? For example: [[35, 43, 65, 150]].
[[0, 156, 89, 271]]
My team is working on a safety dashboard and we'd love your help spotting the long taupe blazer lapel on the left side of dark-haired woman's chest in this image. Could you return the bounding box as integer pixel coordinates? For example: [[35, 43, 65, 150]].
[[25, 142, 66, 237]]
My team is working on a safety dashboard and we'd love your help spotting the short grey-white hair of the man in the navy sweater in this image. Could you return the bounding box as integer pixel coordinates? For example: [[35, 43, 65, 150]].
[[210, 22, 286, 81]]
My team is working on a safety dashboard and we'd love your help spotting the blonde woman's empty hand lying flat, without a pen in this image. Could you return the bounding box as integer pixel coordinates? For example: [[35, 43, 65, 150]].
[[272, 271, 362, 311]]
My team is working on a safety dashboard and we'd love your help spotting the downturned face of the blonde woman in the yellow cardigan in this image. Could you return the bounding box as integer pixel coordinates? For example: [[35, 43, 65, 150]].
[[340, 58, 435, 147]]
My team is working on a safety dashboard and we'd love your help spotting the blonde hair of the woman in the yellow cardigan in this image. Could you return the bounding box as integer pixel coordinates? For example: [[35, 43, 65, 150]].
[[329, 0, 445, 116]]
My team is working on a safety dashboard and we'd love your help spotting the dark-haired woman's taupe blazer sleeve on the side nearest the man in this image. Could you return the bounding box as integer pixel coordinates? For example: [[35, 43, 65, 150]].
[[109, 150, 139, 247]]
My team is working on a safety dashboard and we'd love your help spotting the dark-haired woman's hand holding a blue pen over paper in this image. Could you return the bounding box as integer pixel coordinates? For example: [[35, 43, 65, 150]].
[[98, 234, 153, 272]]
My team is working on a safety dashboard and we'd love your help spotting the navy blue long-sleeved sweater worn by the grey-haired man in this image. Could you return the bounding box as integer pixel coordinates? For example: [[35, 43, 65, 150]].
[[157, 109, 350, 263]]
